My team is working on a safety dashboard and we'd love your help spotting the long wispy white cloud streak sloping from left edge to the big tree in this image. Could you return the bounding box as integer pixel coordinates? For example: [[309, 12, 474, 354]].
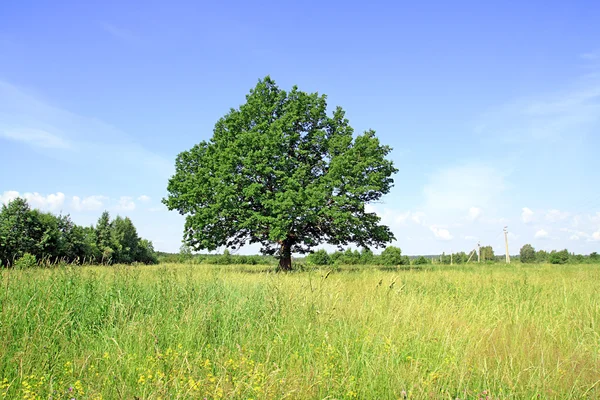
[[0, 81, 173, 179]]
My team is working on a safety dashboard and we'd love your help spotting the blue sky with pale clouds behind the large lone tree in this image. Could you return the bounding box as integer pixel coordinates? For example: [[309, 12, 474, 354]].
[[0, 1, 600, 254]]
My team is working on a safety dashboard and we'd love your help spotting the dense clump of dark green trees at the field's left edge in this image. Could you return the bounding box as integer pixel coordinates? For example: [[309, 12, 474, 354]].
[[0, 198, 158, 266]]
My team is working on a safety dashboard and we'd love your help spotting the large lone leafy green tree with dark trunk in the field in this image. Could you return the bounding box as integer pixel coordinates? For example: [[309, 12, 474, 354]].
[[163, 77, 397, 270]]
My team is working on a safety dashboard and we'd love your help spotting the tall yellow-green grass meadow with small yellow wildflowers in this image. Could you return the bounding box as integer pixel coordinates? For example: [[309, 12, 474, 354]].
[[0, 264, 600, 399]]
